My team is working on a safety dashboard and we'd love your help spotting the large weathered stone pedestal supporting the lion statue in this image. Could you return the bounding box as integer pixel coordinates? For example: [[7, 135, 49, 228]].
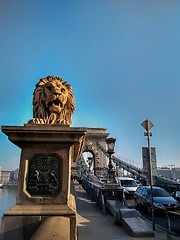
[[1, 125, 86, 240]]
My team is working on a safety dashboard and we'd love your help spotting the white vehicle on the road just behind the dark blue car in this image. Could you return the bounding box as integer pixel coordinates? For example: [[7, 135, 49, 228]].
[[116, 177, 138, 198]]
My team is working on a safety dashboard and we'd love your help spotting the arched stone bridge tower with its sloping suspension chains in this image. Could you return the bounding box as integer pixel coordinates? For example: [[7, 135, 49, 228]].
[[72, 128, 180, 189]]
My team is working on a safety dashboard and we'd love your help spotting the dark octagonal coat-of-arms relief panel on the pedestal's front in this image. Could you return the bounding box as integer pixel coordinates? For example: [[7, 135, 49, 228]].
[[27, 156, 60, 196]]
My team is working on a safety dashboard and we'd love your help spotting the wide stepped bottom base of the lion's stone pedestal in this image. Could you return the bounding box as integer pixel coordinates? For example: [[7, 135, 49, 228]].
[[1, 195, 77, 240]]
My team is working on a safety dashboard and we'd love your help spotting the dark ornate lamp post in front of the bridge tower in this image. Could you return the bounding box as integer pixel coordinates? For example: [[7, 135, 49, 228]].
[[106, 138, 116, 183]]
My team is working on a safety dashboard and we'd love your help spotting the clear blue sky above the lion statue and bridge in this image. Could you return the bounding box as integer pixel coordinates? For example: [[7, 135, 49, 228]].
[[0, 0, 180, 170]]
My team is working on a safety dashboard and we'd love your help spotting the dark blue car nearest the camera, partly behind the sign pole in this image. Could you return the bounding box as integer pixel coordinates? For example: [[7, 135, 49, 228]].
[[134, 186, 180, 213]]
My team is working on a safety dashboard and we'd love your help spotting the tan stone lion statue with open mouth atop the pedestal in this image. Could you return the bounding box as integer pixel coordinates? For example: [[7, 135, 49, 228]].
[[29, 76, 75, 125]]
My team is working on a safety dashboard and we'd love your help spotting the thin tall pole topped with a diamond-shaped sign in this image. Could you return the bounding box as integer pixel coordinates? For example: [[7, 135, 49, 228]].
[[141, 118, 155, 231]]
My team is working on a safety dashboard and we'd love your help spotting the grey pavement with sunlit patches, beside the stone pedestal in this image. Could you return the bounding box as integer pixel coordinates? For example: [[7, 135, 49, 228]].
[[71, 181, 180, 240]]
